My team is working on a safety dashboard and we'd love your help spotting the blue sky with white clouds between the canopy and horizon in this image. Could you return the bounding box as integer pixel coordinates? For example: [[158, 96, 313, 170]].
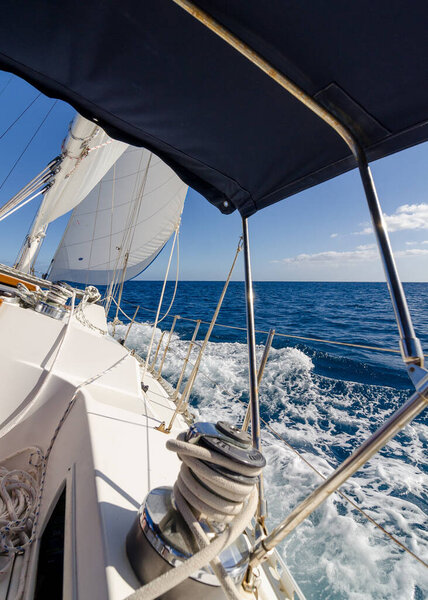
[[0, 72, 428, 281]]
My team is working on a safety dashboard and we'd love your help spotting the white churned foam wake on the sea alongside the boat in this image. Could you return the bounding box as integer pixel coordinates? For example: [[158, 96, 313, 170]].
[[111, 324, 428, 600]]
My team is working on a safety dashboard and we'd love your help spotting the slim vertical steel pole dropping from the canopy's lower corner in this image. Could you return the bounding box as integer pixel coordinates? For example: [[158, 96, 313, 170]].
[[242, 218, 260, 450]]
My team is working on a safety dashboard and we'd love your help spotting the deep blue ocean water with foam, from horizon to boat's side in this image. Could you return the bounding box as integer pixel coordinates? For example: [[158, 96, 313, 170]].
[[111, 281, 428, 600]]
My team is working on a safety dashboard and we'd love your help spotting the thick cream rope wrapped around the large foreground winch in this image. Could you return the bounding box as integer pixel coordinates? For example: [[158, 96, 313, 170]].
[[127, 433, 261, 600]]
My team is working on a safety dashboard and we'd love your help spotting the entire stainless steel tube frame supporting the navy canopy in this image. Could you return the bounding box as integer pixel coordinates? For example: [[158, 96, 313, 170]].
[[172, 0, 428, 566]]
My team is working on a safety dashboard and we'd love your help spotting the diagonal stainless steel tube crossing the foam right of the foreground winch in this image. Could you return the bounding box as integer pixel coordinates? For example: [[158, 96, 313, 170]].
[[250, 381, 428, 566]]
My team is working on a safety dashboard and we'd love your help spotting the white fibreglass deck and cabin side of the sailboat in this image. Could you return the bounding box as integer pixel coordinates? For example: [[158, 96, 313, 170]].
[[0, 296, 300, 600]]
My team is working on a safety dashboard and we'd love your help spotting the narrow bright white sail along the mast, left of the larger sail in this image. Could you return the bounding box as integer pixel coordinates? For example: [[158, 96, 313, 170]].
[[16, 115, 128, 272]]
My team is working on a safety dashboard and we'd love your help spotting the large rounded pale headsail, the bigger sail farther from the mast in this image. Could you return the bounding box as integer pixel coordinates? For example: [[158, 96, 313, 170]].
[[50, 146, 187, 285]]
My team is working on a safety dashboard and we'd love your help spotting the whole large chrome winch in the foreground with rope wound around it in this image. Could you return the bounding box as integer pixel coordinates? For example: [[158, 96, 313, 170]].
[[126, 421, 266, 600]]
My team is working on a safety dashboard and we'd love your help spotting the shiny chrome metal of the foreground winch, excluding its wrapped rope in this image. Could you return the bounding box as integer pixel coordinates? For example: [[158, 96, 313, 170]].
[[126, 422, 265, 600]]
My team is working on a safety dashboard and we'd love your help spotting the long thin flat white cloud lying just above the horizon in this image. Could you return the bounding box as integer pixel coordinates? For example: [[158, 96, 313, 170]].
[[271, 244, 428, 265]]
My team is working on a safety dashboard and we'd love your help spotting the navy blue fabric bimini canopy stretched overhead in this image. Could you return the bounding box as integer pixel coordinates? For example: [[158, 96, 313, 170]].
[[0, 0, 428, 216]]
